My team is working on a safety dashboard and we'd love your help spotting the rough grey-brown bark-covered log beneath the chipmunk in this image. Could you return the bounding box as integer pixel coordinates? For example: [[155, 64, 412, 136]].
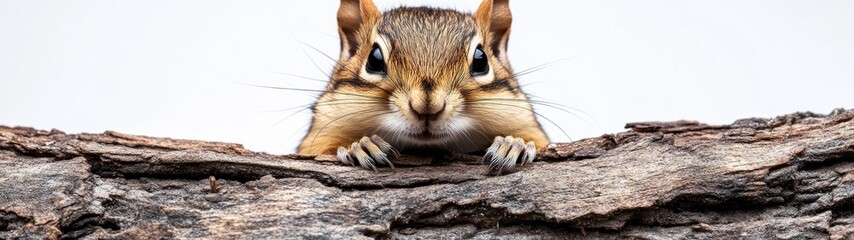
[[0, 110, 854, 239]]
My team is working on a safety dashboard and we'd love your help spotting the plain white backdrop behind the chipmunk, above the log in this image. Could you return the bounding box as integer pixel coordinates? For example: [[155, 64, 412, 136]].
[[0, 0, 854, 153]]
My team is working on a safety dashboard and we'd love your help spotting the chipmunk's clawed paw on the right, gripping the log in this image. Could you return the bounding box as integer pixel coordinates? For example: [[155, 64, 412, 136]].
[[483, 136, 537, 174]]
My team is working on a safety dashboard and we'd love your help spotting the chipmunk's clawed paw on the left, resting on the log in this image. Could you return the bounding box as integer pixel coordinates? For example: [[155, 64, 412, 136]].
[[338, 135, 400, 171]]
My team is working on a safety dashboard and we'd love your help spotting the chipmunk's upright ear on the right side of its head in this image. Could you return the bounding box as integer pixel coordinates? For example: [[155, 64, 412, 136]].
[[474, 0, 513, 62]]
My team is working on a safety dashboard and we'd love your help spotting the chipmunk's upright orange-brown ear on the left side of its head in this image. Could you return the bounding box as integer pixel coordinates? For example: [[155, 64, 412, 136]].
[[338, 0, 382, 59]]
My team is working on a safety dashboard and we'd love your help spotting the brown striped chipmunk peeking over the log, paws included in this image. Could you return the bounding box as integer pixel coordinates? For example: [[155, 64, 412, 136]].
[[298, 0, 549, 174]]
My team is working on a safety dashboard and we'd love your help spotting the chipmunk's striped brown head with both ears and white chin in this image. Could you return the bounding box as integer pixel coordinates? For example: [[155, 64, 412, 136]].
[[321, 0, 531, 150]]
